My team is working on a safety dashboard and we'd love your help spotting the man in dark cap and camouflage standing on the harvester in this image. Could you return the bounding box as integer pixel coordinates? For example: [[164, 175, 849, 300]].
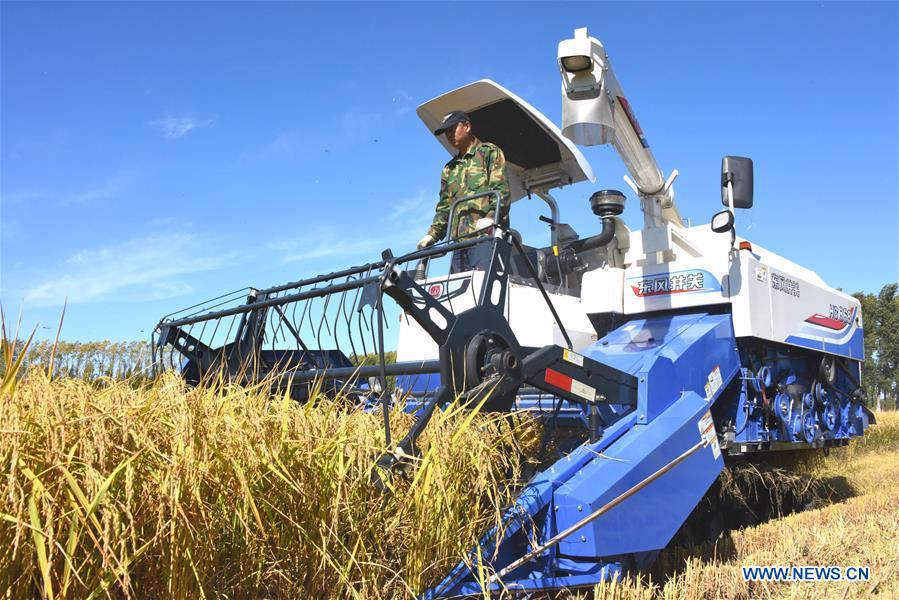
[[418, 110, 511, 272]]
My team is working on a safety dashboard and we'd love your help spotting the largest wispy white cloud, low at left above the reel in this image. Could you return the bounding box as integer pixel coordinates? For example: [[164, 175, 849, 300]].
[[25, 234, 241, 306]]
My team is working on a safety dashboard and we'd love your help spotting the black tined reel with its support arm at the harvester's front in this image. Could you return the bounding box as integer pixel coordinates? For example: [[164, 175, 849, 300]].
[[154, 232, 637, 502]]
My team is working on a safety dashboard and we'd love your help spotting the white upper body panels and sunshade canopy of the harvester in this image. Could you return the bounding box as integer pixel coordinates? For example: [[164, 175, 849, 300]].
[[397, 77, 864, 368]]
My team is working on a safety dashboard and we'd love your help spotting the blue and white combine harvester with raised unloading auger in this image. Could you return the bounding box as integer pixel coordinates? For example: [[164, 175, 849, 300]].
[[154, 29, 873, 597]]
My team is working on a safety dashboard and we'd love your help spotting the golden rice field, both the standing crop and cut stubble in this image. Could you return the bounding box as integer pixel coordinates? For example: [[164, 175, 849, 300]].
[[0, 370, 899, 598]]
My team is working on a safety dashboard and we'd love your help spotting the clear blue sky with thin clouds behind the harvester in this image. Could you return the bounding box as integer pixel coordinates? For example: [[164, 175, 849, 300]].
[[0, 2, 899, 340]]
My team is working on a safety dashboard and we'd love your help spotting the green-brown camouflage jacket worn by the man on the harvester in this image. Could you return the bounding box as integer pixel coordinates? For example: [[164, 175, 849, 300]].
[[428, 138, 511, 241]]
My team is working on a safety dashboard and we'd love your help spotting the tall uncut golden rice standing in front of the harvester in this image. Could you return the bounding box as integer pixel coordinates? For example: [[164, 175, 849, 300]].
[[0, 373, 536, 598]]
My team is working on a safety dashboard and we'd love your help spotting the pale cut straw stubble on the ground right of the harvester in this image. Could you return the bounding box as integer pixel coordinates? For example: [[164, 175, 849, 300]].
[[591, 413, 899, 600]]
